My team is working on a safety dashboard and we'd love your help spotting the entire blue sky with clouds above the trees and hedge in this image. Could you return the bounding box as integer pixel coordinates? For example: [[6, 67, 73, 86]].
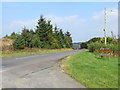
[[2, 2, 118, 42]]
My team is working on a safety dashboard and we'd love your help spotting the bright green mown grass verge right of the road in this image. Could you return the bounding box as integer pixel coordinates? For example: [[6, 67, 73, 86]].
[[60, 51, 118, 88]]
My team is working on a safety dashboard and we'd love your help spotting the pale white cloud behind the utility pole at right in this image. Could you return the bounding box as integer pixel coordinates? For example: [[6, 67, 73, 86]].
[[92, 9, 118, 36]]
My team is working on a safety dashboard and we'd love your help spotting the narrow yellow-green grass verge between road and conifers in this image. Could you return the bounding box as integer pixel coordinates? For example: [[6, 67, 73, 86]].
[[0, 48, 73, 58]]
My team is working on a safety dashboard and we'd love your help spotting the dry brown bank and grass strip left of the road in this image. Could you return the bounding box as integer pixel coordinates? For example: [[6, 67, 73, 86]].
[[0, 39, 72, 58]]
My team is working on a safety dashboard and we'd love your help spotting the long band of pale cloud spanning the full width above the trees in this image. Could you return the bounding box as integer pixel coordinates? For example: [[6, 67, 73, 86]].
[[3, 9, 118, 42]]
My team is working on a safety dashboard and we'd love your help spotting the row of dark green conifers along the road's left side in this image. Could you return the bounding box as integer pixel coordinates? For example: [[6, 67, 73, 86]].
[[6, 15, 72, 49]]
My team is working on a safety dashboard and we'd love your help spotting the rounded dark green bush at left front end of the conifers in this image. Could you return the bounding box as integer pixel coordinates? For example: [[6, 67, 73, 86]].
[[13, 36, 25, 49]]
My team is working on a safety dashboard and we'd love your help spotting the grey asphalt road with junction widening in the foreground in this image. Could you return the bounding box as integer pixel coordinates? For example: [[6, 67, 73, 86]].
[[1, 50, 85, 88]]
